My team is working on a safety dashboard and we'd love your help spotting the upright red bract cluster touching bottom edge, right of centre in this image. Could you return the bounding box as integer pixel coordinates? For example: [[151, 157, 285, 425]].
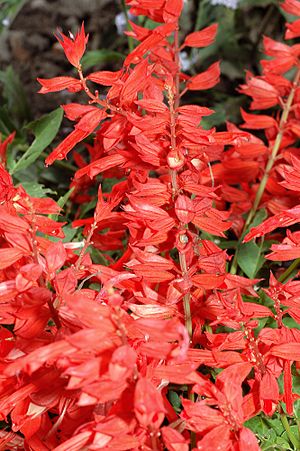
[[182, 363, 259, 451]]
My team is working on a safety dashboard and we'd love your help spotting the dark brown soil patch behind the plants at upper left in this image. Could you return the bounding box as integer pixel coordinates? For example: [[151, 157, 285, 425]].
[[0, 0, 125, 118]]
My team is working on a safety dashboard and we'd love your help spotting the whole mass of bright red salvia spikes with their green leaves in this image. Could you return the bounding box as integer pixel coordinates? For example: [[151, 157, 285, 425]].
[[0, 0, 300, 451]]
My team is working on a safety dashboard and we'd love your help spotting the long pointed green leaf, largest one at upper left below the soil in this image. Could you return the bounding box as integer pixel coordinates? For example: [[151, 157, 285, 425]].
[[11, 108, 63, 174]]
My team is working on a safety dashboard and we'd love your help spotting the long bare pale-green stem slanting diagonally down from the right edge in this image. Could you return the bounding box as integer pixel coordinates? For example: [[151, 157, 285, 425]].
[[230, 69, 300, 274]]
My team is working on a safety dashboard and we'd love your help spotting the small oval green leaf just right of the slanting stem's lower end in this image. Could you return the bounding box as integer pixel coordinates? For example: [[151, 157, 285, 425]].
[[237, 241, 264, 279]]
